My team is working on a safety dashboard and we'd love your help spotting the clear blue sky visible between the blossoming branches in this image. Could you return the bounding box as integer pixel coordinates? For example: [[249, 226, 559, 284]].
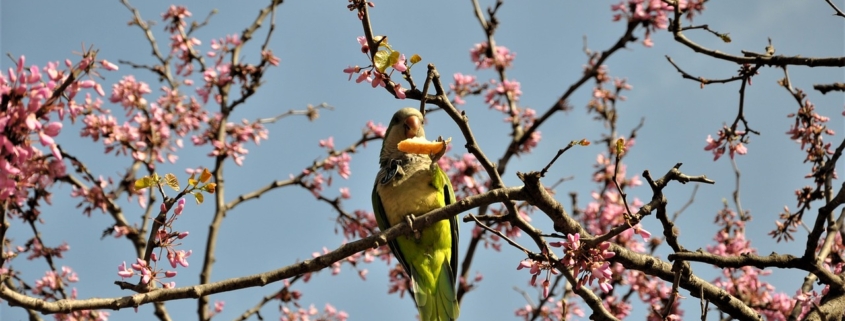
[[0, 0, 845, 320]]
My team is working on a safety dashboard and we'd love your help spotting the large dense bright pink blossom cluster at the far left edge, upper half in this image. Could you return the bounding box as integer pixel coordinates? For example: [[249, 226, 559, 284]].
[[0, 53, 110, 205]]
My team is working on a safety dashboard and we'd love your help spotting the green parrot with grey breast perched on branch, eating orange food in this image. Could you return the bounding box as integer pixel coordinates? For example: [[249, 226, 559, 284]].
[[372, 107, 460, 321]]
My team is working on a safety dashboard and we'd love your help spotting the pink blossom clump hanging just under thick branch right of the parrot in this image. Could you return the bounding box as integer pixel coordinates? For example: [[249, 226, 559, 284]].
[[549, 234, 616, 292]]
